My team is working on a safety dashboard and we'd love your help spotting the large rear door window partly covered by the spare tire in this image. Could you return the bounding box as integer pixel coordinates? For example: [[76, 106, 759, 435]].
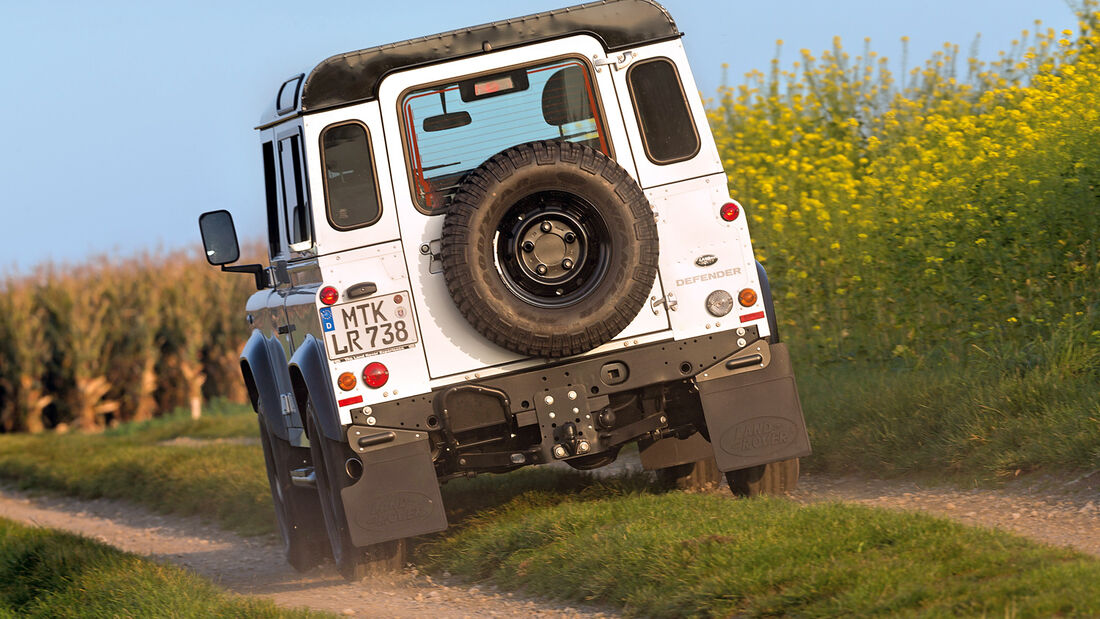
[[402, 59, 611, 213]]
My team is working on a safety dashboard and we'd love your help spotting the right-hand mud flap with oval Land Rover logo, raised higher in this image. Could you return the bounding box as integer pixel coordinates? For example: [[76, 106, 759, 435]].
[[695, 340, 810, 472]]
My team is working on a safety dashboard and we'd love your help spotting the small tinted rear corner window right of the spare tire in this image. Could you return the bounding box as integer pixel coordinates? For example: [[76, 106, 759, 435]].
[[627, 58, 700, 164]]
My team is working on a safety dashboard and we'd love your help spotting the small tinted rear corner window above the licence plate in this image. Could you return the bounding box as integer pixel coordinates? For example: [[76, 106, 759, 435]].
[[321, 122, 382, 230]]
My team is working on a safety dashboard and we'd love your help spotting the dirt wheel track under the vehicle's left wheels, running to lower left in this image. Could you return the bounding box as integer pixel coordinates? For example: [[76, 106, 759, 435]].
[[0, 488, 616, 619]]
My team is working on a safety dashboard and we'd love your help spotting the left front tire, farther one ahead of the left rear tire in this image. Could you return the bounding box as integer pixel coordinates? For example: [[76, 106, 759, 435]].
[[257, 413, 329, 572]]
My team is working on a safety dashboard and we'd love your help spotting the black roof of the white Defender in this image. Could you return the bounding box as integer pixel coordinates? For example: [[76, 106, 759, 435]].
[[262, 0, 681, 124]]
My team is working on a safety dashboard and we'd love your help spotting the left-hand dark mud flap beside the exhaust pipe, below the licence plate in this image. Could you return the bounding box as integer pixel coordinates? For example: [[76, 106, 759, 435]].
[[341, 425, 447, 546]]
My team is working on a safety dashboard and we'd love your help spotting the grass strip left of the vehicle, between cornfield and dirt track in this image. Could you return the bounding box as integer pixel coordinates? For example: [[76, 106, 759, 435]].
[[0, 405, 275, 534]]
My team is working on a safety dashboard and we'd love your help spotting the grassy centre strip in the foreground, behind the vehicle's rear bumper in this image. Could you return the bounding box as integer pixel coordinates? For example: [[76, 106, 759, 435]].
[[418, 474, 1100, 617]]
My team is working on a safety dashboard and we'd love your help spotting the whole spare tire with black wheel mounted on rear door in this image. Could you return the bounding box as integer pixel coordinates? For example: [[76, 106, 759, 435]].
[[441, 141, 659, 357]]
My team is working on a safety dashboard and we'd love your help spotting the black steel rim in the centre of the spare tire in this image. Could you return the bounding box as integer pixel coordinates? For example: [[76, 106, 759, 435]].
[[494, 190, 612, 308]]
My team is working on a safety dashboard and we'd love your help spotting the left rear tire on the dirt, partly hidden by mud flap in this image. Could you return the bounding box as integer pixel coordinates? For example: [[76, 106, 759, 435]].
[[306, 402, 408, 582]]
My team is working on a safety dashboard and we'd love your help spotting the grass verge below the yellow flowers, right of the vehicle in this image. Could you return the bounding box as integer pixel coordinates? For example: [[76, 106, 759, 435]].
[[796, 327, 1100, 483]]
